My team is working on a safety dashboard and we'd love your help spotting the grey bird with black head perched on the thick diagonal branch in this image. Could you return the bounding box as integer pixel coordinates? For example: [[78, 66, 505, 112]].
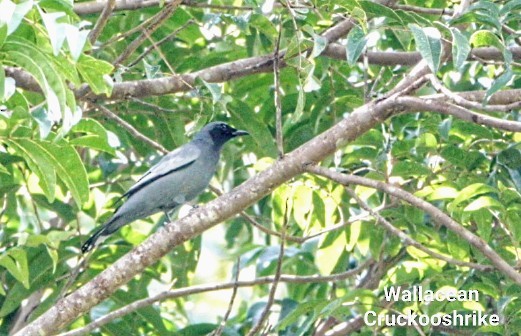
[[81, 121, 249, 254]]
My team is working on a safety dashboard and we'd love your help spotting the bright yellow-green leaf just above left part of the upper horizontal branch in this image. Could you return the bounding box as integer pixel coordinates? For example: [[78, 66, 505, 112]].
[[76, 55, 114, 97]]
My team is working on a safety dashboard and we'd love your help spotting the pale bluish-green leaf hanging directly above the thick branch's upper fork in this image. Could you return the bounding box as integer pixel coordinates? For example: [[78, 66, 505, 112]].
[[408, 24, 441, 73]]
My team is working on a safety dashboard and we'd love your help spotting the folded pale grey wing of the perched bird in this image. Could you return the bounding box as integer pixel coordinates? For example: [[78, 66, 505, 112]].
[[122, 144, 201, 197]]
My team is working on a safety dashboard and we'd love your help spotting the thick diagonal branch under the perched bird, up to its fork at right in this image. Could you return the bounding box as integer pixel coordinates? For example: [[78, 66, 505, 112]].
[[13, 82, 402, 336]]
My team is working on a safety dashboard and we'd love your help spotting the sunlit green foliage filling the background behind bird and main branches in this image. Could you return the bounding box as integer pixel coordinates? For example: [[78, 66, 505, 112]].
[[0, 0, 521, 335]]
